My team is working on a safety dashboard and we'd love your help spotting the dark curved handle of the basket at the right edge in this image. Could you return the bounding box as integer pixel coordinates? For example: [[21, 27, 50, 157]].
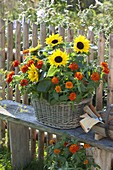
[[105, 104, 113, 140]]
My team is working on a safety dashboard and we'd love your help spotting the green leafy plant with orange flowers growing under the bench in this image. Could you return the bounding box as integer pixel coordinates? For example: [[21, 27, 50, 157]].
[[45, 135, 99, 170]]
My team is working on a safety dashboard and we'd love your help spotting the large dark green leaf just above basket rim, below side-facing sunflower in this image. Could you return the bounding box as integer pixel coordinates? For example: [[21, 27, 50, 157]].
[[37, 80, 51, 93]]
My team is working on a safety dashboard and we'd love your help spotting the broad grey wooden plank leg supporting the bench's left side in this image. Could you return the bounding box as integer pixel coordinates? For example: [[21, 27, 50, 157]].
[[9, 122, 31, 170]]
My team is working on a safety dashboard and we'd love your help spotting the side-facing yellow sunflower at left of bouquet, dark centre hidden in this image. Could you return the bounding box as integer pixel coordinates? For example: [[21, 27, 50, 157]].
[[28, 64, 39, 82]]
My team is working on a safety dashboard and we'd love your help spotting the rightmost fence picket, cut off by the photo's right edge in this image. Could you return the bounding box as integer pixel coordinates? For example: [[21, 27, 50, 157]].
[[107, 34, 113, 105]]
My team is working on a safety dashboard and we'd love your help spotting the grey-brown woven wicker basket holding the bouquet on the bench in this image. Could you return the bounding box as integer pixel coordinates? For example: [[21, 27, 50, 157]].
[[32, 98, 91, 129]]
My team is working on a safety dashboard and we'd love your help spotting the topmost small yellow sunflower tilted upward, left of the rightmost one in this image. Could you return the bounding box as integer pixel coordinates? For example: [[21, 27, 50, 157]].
[[46, 34, 63, 47]]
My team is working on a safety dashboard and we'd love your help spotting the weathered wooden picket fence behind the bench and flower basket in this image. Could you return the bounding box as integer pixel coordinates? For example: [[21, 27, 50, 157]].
[[0, 19, 113, 169]]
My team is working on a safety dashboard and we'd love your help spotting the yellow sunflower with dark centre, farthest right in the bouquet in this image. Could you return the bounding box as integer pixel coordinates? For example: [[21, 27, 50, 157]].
[[74, 35, 90, 53]]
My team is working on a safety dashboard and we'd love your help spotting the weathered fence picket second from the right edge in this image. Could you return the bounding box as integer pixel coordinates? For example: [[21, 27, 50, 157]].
[[96, 32, 105, 111]]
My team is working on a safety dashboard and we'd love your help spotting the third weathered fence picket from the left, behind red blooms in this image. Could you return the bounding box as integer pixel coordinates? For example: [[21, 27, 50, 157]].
[[15, 21, 21, 102]]
